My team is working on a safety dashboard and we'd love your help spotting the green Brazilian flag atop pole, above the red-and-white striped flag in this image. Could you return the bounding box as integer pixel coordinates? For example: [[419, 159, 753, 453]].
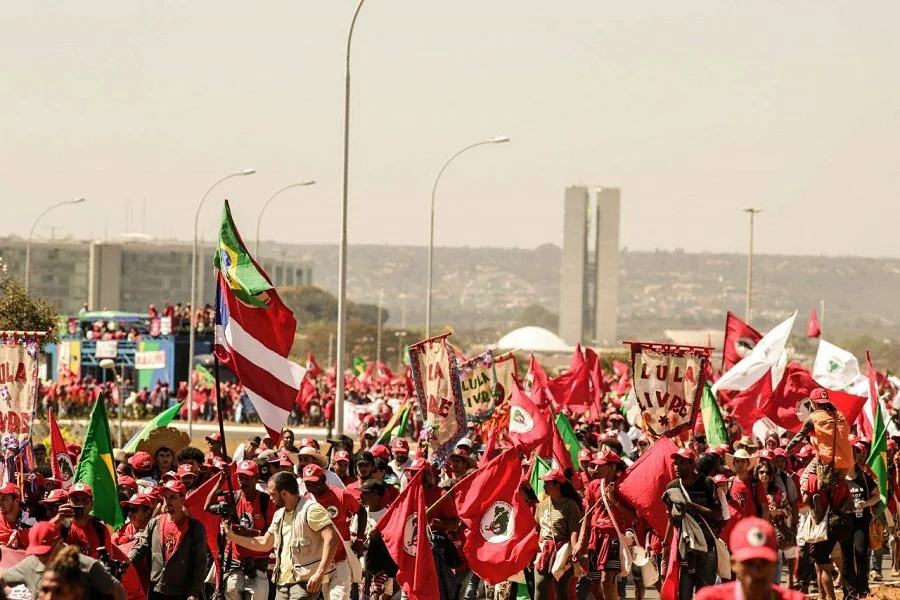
[[215, 200, 272, 308]]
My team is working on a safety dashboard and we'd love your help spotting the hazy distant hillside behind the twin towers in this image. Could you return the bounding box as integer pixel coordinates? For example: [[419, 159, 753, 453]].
[[264, 244, 900, 339]]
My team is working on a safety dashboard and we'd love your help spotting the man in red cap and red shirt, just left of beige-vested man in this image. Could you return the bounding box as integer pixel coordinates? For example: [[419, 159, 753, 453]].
[[206, 460, 275, 600]]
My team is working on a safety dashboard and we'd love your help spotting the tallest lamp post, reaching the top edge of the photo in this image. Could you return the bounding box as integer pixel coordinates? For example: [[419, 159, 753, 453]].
[[334, 0, 366, 435]]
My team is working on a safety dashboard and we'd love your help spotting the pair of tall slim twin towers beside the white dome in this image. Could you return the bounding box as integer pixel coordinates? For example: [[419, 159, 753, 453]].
[[559, 186, 620, 347]]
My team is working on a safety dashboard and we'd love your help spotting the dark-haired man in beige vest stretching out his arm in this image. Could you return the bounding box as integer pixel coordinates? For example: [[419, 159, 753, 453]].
[[225, 473, 341, 600]]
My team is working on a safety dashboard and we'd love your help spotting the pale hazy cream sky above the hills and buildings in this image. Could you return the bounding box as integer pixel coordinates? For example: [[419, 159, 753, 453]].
[[0, 0, 900, 256]]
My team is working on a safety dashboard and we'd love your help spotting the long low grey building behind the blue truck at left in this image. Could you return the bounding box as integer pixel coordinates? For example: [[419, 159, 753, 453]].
[[0, 238, 313, 315]]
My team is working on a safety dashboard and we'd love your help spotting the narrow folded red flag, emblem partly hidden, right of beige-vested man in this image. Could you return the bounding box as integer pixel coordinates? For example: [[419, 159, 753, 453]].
[[376, 471, 441, 600]]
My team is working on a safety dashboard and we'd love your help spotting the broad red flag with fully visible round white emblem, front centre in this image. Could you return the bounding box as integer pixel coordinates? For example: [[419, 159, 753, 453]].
[[454, 449, 538, 585]]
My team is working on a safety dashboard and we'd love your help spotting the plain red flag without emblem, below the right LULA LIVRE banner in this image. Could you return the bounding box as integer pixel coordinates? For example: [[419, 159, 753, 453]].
[[616, 437, 678, 537]]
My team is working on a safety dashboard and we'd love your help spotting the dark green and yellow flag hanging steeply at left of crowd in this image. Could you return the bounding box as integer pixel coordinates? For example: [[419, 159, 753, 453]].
[[70, 396, 125, 529]]
